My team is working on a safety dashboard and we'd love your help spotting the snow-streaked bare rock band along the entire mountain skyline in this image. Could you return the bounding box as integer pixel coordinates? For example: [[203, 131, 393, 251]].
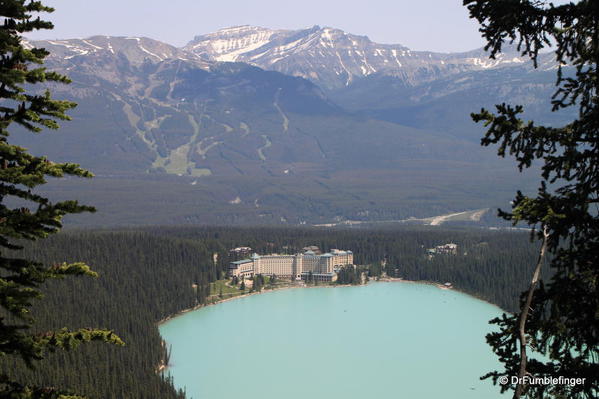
[[32, 26, 555, 90]]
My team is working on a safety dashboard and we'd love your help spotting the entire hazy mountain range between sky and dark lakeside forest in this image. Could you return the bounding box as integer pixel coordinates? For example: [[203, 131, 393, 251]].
[[17, 26, 568, 228]]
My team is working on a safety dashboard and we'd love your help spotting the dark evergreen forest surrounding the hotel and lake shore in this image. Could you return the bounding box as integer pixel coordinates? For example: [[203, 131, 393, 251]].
[[0, 227, 536, 399]]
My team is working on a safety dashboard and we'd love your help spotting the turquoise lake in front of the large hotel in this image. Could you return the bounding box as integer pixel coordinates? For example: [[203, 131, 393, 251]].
[[160, 283, 507, 399]]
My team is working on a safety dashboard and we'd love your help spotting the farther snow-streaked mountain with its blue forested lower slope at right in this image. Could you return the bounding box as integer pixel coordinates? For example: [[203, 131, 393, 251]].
[[185, 26, 573, 141]]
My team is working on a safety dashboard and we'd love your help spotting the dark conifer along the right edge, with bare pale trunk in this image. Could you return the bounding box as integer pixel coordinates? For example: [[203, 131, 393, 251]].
[[464, 0, 599, 398]]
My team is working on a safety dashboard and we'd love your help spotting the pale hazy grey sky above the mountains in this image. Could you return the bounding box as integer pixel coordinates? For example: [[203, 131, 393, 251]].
[[27, 0, 483, 52]]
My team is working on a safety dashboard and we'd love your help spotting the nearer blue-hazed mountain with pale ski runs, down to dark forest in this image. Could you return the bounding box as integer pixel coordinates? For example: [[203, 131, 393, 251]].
[[13, 32, 544, 225]]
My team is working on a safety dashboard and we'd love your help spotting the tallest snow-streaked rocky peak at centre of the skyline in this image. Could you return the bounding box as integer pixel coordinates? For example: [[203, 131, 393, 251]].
[[185, 25, 434, 87]]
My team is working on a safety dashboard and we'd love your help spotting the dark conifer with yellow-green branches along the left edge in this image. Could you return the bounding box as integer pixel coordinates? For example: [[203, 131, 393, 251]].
[[0, 0, 123, 399]]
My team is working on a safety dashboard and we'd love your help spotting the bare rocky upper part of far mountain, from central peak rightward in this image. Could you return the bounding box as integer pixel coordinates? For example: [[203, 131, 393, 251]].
[[184, 26, 552, 89]]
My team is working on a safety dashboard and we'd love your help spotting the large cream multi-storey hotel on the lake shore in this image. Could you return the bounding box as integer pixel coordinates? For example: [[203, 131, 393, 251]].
[[229, 249, 354, 281]]
